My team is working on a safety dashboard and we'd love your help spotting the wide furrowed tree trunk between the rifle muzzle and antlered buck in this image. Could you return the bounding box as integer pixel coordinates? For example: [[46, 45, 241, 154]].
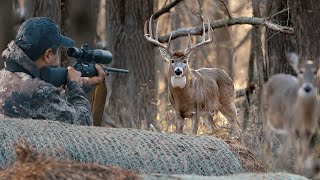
[[105, 0, 156, 128]]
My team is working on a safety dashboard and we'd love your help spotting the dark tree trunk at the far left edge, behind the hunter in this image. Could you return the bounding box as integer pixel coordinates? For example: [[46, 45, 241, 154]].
[[0, 0, 14, 69]]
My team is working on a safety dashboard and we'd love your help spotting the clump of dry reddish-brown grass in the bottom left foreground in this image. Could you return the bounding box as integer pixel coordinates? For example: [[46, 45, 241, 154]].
[[0, 143, 138, 180]]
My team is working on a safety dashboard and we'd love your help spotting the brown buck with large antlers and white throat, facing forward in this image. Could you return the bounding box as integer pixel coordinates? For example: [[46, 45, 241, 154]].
[[144, 16, 240, 134]]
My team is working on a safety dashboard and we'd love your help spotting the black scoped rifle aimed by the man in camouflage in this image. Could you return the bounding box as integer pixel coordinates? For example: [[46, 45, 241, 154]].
[[40, 44, 129, 87]]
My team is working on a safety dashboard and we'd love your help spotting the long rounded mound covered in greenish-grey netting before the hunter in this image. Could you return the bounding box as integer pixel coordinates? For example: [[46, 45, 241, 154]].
[[0, 118, 245, 175]]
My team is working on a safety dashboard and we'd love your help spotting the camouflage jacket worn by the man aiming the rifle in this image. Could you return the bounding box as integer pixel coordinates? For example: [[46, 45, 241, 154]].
[[0, 41, 92, 125]]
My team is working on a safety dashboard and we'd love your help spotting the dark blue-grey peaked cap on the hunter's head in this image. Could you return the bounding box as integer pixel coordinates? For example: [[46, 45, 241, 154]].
[[15, 17, 74, 61]]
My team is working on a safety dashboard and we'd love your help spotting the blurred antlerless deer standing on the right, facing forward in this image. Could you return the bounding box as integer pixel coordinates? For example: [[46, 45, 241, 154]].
[[262, 53, 319, 172]]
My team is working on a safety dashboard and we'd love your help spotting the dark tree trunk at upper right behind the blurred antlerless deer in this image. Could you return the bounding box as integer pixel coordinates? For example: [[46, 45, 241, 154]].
[[266, 0, 320, 76]]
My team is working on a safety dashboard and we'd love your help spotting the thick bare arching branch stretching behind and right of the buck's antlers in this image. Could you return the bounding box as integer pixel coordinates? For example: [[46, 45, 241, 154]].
[[159, 17, 294, 42]]
